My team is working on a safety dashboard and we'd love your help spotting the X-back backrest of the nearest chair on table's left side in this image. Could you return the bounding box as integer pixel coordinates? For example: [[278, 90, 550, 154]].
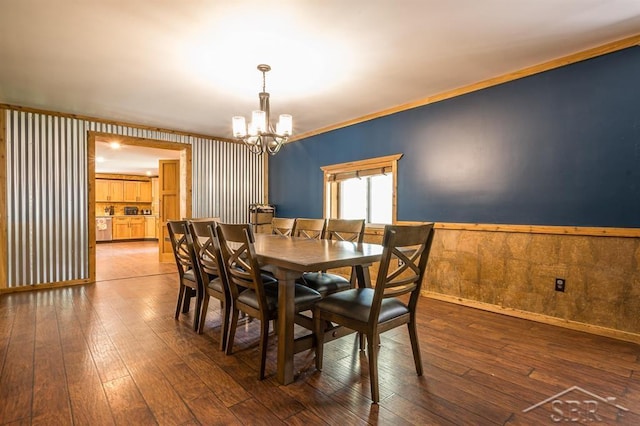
[[212, 223, 266, 302]]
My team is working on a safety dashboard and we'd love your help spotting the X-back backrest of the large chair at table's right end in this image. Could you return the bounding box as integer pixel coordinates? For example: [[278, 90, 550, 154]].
[[369, 223, 434, 321]]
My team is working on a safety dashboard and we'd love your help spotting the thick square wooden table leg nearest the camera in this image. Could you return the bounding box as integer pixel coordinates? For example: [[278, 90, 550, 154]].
[[274, 268, 300, 385]]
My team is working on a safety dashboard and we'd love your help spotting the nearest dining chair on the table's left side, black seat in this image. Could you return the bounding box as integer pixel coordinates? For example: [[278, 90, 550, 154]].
[[215, 223, 320, 380]]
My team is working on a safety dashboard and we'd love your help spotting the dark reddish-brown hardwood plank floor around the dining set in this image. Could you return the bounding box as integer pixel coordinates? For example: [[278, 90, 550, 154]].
[[0, 243, 640, 425]]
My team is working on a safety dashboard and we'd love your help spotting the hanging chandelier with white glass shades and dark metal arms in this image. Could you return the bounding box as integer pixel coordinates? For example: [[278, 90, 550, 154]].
[[232, 64, 293, 155]]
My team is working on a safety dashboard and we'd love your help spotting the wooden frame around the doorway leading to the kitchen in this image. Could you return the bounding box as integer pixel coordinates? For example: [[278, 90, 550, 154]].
[[87, 131, 192, 282]]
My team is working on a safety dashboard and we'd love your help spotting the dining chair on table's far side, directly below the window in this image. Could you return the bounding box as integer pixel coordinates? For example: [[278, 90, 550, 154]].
[[298, 219, 364, 297]]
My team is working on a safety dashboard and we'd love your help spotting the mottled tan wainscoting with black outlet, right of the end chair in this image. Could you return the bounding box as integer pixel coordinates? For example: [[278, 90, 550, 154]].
[[384, 222, 640, 342]]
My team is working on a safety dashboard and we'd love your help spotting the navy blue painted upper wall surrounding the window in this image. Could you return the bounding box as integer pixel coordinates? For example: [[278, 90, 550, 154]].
[[269, 47, 640, 227]]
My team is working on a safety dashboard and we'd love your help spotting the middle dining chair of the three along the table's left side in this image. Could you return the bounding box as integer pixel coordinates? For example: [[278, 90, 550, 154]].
[[189, 220, 231, 350]]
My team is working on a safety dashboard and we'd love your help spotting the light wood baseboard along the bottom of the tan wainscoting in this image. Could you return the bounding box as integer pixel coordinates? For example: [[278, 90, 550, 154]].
[[422, 291, 640, 344]]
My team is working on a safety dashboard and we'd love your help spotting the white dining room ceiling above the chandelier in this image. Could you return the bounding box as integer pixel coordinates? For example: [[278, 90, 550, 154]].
[[0, 0, 640, 143]]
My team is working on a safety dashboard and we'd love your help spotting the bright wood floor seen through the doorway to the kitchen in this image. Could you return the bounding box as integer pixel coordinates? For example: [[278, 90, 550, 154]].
[[96, 241, 176, 282]]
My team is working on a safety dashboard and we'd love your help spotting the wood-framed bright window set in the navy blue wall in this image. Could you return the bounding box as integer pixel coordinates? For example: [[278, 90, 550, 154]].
[[321, 154, 402, 224]]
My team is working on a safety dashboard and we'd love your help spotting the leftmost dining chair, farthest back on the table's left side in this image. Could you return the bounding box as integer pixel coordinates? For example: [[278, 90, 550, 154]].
[[167, 220, 204, 331]]
